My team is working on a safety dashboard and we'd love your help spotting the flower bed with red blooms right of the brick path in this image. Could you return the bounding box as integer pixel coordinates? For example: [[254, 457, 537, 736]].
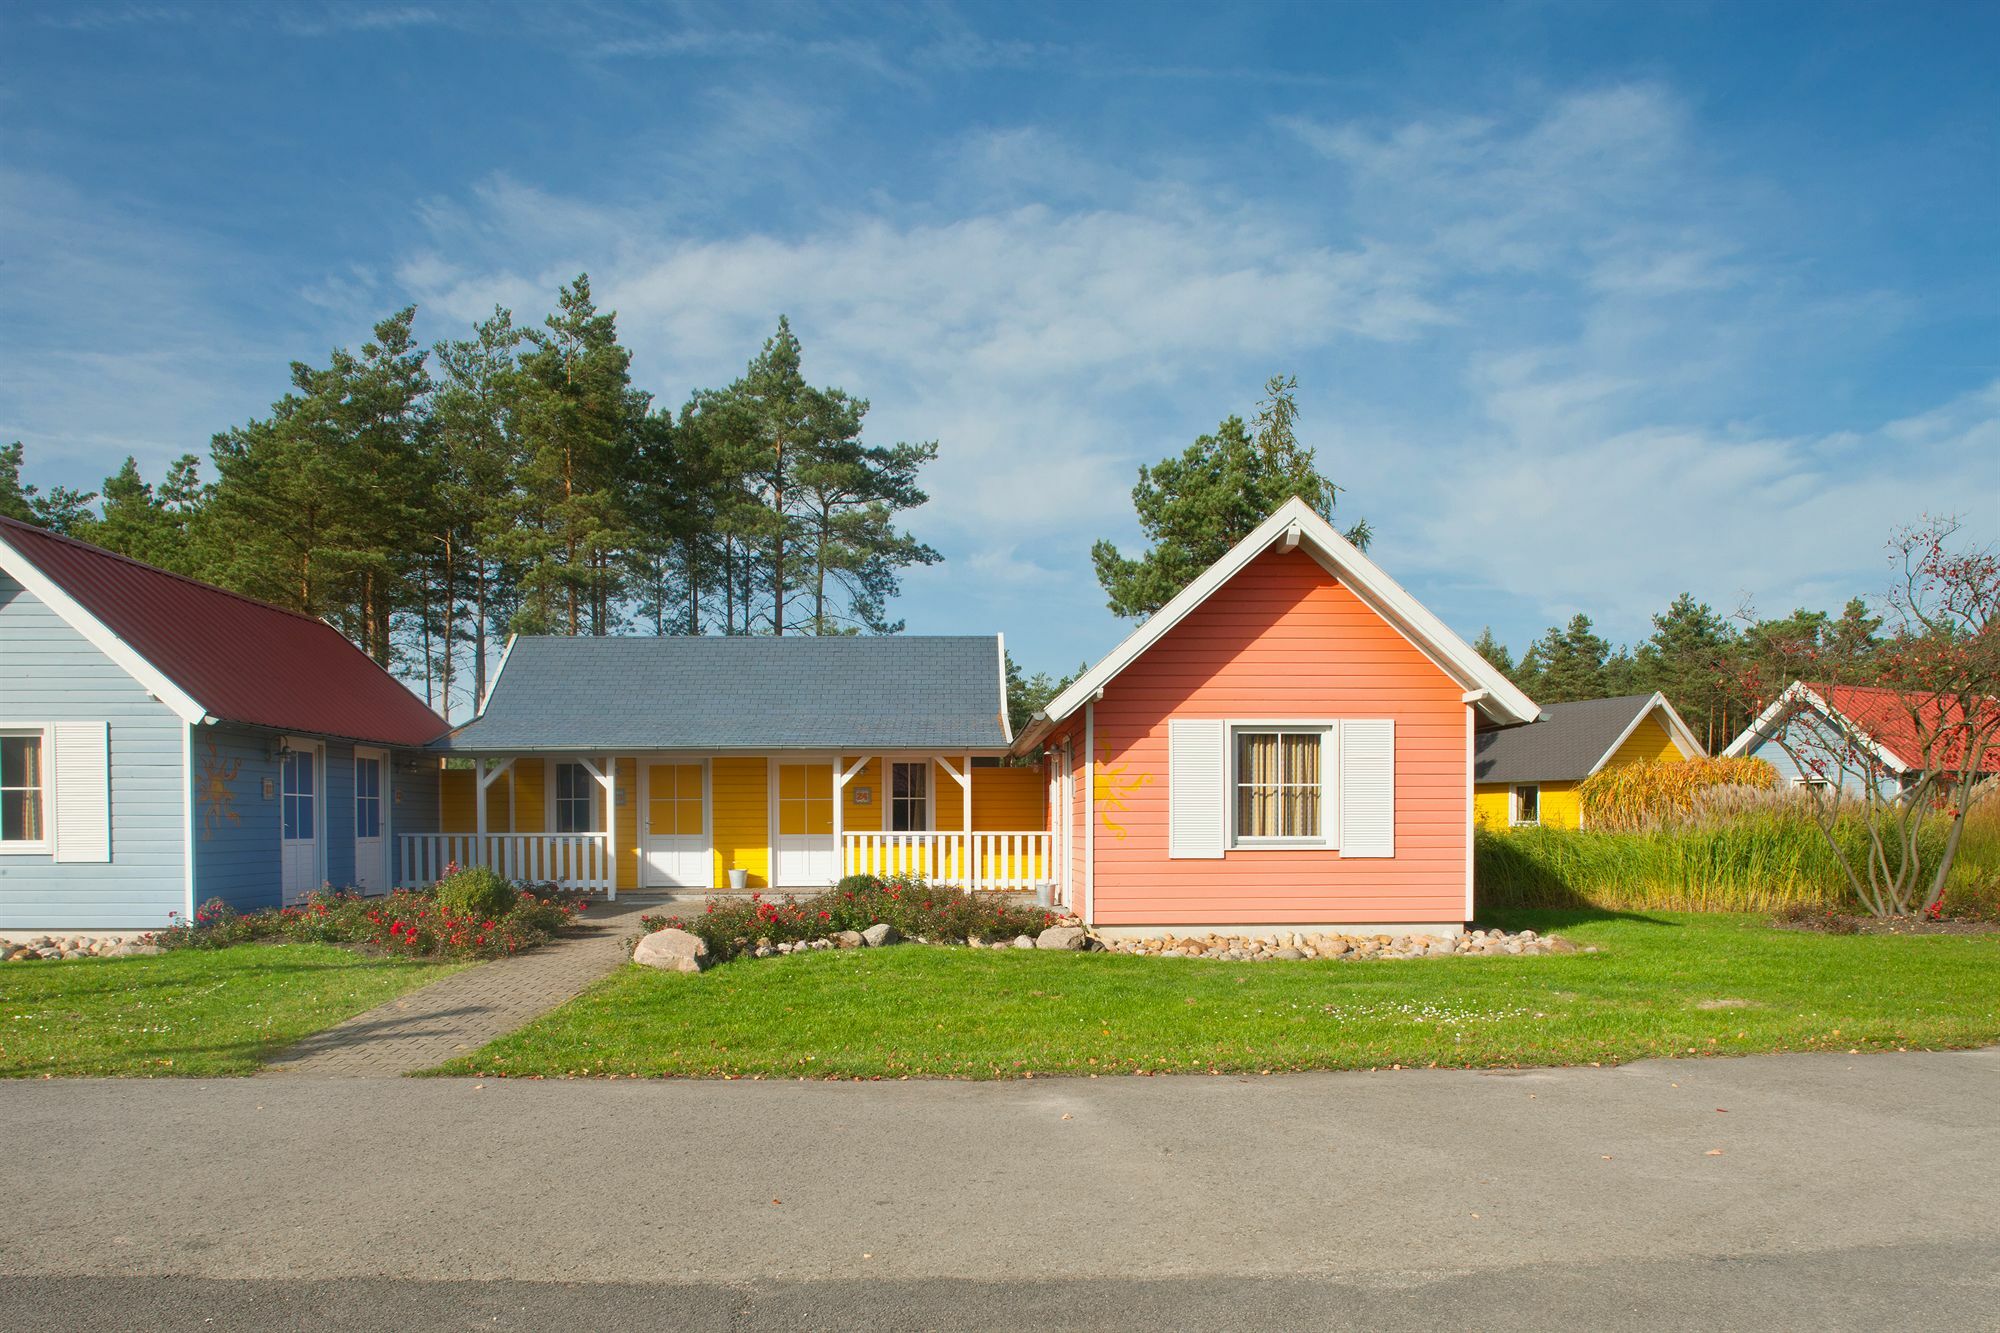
[[640, 875, 1062, 963]]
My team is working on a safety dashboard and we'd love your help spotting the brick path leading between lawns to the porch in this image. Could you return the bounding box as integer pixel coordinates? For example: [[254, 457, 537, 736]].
[[264, 899, 656, 1079]]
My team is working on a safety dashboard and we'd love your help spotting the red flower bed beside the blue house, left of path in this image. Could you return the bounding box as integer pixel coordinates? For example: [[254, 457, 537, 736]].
[[152, 887, 588, 959]]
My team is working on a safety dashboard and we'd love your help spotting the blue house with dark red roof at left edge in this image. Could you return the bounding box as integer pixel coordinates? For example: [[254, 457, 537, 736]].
[[0, 518, 446, 933]]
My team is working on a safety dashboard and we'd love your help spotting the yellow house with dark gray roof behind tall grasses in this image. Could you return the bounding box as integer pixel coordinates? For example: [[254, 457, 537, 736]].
[[1472, 693, 1706, 829]]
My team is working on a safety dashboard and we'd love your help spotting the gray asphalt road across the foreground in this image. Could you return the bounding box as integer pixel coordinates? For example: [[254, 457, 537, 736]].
[[0, 1051, 2000, 1329]]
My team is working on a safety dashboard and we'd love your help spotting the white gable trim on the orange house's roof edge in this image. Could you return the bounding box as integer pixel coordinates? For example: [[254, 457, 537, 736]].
[[1042, 498, 1542, 723]]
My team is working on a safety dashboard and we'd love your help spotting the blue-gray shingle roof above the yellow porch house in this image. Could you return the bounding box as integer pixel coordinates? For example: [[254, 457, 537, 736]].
[[434, 634, 1008, 753]]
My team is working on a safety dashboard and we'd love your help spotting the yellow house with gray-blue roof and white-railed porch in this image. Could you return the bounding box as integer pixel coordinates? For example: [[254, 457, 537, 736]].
[[420, 634, 1056, 897]]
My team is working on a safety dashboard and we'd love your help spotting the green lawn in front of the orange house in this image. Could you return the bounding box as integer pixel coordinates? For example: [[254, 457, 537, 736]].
[[440, 913, 2000, 1079]]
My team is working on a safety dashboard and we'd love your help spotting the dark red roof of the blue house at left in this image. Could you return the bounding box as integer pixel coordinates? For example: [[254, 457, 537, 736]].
[[0, 518, 446, 747]]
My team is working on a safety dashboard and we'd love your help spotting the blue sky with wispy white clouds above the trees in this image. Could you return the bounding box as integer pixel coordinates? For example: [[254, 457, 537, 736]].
[[0, 0, 2000, 669]]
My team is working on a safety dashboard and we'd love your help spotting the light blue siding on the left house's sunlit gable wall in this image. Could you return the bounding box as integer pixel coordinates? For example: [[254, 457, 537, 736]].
[[0, 574, 186, 933]]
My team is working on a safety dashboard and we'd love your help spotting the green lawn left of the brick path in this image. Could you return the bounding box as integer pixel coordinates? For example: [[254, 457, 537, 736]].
[[0, 945, 464, 1079]]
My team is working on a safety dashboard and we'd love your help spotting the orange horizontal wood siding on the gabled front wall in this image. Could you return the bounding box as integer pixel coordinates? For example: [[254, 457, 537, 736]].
[[1094, 552, 1472, 925]]
